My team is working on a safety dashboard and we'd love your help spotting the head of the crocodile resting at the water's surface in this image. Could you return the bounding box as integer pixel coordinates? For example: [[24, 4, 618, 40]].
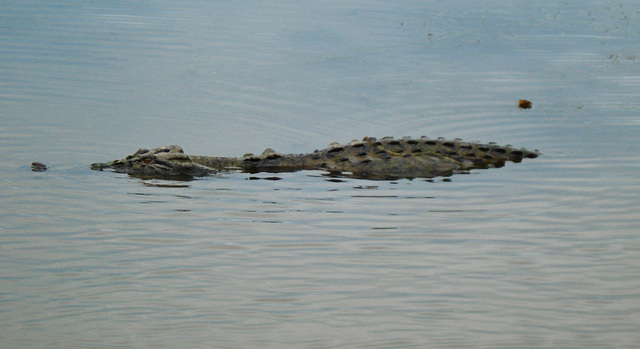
[[91, 145, 216, 179]]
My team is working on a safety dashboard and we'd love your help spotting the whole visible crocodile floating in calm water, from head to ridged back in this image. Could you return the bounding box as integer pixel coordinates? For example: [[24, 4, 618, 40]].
[[91, 137, 539, 179]]
